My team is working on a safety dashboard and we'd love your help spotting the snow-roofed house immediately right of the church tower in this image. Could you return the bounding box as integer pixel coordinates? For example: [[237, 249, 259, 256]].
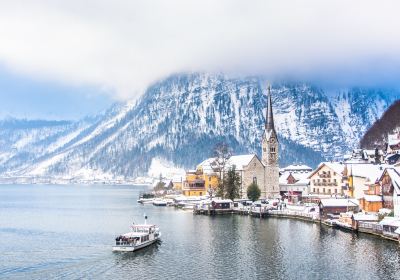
[[279, 165, 312, 203]]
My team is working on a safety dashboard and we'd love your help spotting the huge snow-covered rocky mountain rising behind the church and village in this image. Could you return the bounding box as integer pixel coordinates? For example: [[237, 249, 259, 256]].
[[0, 73, 399, 180]]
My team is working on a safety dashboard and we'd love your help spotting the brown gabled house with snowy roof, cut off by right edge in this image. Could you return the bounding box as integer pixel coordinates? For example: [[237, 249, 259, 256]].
[[379, 168, 400, 217]]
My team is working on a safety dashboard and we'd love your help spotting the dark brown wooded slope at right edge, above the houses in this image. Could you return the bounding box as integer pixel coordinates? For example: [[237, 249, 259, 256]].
[[360, 100, 400, 149]]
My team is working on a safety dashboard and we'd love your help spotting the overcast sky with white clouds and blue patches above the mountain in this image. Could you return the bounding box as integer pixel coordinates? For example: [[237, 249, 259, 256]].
[[0, 0, 400, 117]]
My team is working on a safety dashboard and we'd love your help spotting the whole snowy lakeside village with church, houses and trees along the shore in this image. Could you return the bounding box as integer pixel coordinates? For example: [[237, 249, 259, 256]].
[[142, 87, 400, 241]]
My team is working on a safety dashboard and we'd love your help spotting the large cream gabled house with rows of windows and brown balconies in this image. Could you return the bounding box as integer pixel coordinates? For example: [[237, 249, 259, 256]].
[[307, 162, 344, 196]]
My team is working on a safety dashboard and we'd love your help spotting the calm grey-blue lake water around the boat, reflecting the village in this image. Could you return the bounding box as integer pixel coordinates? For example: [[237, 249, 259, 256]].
[[0, 185, 400, 279]]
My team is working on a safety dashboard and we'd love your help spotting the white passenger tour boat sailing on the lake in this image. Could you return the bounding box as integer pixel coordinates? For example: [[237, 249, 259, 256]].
[[113, 220, 161, 252]]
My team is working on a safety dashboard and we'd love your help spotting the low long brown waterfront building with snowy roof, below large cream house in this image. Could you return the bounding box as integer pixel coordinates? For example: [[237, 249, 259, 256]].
[[319, 198, 360, 219]]
